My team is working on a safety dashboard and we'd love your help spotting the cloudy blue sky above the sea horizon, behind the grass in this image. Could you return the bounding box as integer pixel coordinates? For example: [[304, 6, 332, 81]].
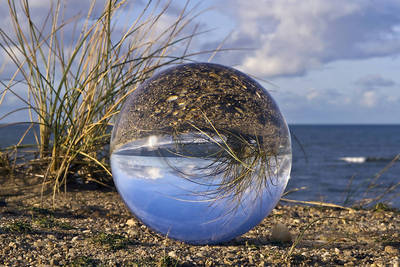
[[0, 0, 400, 124]]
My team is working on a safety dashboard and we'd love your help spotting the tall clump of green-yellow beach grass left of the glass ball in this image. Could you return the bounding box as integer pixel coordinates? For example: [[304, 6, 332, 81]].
[[0, 0, 211, 199]]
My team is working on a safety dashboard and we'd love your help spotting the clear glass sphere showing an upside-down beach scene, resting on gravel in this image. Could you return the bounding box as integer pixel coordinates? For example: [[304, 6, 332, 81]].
[[110, 63, 292, 244]]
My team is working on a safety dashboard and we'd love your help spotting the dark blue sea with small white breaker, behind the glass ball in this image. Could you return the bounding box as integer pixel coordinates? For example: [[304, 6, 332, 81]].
[[0, 125, 400, 208]]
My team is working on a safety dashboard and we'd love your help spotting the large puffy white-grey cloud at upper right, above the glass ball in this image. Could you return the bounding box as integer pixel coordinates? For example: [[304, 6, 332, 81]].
[[216, 0, 400, 77]]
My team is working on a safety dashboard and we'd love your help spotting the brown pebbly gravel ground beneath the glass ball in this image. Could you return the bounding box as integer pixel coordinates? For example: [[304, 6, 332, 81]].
[[0, 181, 400, 266]]
